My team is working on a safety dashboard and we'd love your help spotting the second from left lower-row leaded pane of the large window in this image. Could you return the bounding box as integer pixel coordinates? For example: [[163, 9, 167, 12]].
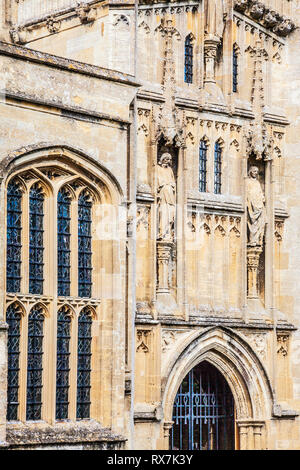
[[26, 305, 44, 420]]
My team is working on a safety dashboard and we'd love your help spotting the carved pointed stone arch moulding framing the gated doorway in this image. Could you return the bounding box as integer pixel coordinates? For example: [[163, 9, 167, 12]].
[[162, 327, 274, 450]]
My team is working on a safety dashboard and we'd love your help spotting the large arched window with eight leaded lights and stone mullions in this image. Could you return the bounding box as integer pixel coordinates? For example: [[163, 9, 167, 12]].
[[6, 157, 101, 422]]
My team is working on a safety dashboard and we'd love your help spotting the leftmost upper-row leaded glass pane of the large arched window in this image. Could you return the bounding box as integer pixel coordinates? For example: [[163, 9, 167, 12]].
[[6, 181, 22, 292]]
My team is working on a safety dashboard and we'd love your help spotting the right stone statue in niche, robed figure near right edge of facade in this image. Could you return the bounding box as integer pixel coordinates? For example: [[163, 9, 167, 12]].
[[246, 166, 266, 247]]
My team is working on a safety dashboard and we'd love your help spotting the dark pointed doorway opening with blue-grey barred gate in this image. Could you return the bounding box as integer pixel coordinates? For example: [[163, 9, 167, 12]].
[[170, 361, 235, 450]]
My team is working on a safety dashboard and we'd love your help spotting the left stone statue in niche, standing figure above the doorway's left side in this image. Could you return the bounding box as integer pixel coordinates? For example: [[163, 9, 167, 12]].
[[157, 153, 176, 241]]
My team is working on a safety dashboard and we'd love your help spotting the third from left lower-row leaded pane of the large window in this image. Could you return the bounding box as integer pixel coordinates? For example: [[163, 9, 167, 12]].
[[56, 307, 71, 419]]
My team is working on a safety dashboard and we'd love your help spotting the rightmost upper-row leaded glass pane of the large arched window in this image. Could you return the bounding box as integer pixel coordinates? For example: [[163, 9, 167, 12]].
[[78, 191, 92, 297]]
